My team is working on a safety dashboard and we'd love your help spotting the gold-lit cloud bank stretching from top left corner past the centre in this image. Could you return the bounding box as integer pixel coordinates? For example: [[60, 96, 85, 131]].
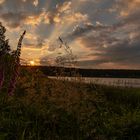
[[0, 0, 87, 28]]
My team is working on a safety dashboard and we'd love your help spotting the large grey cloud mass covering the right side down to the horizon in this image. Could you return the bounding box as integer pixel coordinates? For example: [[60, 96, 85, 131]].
[[68, 2, 140, 68]]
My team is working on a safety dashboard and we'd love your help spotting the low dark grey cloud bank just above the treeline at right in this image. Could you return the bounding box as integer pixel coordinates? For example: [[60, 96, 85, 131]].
[[78, 39, 140, 68]]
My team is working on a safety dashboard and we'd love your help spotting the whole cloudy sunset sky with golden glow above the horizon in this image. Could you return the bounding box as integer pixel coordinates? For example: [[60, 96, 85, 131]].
[[0, 0, 140, 69]]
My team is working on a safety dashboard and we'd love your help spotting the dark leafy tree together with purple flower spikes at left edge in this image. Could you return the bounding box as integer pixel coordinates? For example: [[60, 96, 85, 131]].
[[0, 23, 26, 95]]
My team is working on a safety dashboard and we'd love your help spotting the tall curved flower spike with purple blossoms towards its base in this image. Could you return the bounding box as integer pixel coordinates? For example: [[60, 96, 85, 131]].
[[8, 31, 26, 96]]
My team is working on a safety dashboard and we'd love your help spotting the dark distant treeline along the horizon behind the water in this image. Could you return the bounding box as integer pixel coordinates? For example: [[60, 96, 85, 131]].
[[22, 66, 140, 78]]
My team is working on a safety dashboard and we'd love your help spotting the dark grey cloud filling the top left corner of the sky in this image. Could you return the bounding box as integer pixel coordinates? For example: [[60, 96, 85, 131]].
[[0, 0, 41, 28]]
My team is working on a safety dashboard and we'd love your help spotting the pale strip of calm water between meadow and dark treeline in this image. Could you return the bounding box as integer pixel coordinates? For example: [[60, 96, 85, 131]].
[[48, 76, 140, 88]]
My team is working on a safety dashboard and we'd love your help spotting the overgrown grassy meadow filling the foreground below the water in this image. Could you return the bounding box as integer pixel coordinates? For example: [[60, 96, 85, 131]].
[[0, 70, 140, 140]]
